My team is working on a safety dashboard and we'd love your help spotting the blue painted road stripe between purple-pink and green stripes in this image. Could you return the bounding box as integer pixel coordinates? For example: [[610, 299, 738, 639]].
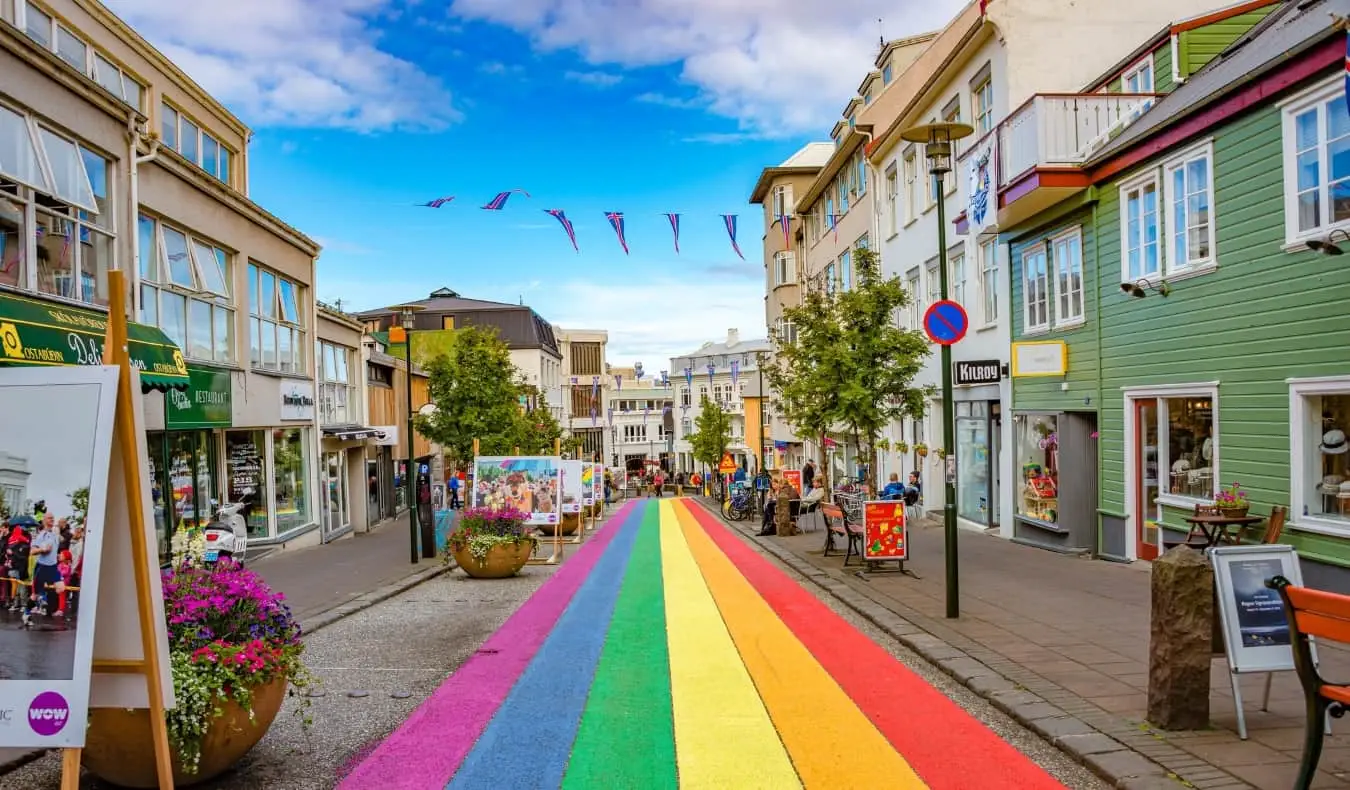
[[447, 502, 652, 790]]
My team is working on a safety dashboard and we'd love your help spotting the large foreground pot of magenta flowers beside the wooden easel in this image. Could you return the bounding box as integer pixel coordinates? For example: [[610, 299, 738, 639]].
[[84, 560, 313, 787]]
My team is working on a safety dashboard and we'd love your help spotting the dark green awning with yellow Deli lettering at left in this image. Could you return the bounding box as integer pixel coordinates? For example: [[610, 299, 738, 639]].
[[0, 287, 188, 390]]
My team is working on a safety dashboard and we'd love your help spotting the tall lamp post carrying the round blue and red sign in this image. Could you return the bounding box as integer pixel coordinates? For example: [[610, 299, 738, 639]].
[[900, 123, 975, 620]]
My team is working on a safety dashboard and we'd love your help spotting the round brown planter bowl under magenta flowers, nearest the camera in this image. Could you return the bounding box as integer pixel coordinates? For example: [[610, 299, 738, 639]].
[[81, 678, 286, 787]]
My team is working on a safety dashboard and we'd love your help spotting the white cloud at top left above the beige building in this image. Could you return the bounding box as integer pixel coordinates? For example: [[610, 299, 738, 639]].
[[107, 0, 460, 131]]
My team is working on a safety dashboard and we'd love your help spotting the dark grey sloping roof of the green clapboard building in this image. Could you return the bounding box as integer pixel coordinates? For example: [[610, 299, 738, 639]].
[[1084, 0, 1350, 162]]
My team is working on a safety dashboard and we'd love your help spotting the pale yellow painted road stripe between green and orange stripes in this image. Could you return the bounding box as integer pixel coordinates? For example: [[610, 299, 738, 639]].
[[656, 500, 802, 790]]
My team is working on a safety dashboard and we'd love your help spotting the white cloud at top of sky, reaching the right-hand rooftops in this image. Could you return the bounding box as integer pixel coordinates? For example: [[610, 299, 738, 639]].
[[451, 0, 964, 134]]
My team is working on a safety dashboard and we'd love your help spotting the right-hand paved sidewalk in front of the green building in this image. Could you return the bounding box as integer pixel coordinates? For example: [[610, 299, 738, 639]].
[[734, 505, 1350, 790]]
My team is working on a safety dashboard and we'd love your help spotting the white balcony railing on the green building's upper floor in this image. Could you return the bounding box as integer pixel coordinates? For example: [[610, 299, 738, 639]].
[[998, 93, 1157, 186]]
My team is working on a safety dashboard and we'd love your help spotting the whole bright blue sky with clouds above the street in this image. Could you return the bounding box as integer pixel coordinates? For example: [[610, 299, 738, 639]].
[[108, 0, 953, 356]]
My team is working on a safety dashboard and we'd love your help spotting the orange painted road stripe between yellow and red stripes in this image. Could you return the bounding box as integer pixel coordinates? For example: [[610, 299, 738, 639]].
[[676, 505, 927, 790]]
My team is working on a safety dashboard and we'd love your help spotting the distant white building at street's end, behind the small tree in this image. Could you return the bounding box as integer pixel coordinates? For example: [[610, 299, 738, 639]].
[[670, 330, 774, 471]]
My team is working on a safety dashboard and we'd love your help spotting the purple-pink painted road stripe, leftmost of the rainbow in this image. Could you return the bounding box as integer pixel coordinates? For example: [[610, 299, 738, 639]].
[[338, 500, 637, 790]]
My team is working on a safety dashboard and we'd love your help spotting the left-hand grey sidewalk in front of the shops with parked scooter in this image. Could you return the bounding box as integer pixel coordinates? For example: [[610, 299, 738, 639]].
[[248, 513, 452, 632]]
